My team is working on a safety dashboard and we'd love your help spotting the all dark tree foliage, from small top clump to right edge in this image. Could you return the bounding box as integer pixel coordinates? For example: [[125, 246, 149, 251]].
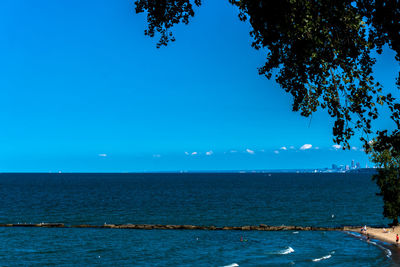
[[135, 0, 400, 221]]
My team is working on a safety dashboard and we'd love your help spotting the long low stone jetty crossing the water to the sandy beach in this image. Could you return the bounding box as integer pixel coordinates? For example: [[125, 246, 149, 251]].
[[0, 223, 361, 231]]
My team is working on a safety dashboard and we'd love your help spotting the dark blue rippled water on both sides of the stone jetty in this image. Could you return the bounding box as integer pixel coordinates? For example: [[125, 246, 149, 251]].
[[0, 173, 400, 266]]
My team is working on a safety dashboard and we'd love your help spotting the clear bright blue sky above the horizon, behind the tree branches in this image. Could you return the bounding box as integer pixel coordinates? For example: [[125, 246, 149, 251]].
[[0, 0, 399, 172]]
